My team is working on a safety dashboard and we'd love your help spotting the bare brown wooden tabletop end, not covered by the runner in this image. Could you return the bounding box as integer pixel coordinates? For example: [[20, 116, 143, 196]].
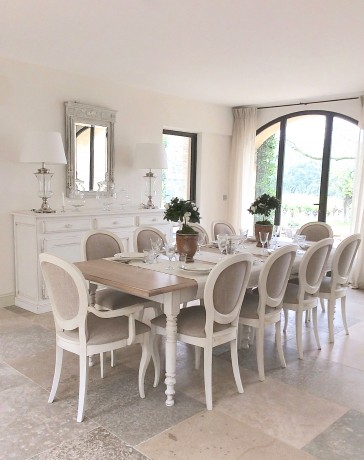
[[74, 259, 197, 298]]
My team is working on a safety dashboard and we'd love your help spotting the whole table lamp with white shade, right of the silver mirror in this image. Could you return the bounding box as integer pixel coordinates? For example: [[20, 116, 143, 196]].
[[134, 143, 168, 209]]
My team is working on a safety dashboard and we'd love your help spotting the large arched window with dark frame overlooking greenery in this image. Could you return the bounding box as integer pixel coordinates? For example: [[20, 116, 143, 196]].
[[255, 110, 359, 235]]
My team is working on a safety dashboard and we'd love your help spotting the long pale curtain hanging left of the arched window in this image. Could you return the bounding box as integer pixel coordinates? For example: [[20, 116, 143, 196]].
[[228, 107, 257, 231]]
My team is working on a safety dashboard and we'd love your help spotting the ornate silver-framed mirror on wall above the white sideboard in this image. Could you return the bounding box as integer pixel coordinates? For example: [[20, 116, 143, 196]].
[[65, 102, 116, 196]]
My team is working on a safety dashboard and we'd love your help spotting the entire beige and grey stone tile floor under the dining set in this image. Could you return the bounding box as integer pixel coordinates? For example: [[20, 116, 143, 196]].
[[0, 290, 364, 460]]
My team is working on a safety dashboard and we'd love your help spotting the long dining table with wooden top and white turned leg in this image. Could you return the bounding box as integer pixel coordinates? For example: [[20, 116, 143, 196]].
[[75, 243, 301, 406]]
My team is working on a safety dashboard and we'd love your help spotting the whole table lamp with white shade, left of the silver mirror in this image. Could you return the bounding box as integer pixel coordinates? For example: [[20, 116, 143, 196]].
[[20, 131, 67, 213]]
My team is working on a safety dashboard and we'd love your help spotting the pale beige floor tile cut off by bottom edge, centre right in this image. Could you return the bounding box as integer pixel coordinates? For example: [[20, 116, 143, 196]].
[[137, 410, 314, 460]]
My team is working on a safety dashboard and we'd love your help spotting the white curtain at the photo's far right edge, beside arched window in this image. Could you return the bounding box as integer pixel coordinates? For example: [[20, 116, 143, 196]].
[[351, 96, 364, 289]]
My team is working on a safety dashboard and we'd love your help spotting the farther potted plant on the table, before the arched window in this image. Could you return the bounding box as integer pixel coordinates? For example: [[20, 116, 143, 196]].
[[248, 193, 280, 247]]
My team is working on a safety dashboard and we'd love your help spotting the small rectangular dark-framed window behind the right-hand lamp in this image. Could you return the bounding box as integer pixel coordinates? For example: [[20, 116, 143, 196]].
[[162, 129, 197, 206]]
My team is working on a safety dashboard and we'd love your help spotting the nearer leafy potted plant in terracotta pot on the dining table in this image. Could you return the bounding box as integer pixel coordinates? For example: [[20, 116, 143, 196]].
[[163, 197, 200, 262]]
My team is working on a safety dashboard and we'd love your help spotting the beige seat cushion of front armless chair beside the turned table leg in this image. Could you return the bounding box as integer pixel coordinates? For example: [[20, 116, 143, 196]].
[[152, 305, 231, 337]]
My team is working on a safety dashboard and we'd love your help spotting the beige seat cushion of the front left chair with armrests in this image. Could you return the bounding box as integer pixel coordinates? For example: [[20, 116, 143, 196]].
[[63, 313, 150, 345]]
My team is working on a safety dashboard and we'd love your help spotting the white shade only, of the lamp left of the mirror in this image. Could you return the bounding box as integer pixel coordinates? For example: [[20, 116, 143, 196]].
[[20, 131, 67, 164]]
